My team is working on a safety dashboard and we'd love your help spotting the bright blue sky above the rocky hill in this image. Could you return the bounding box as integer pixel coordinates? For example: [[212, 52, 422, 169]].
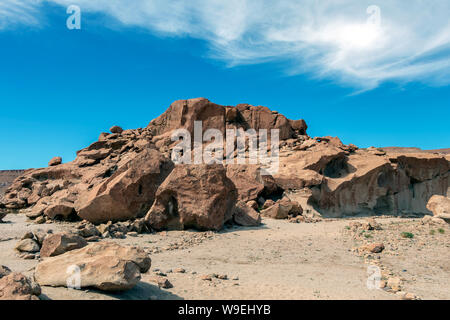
[[0, 0, 450, 169]]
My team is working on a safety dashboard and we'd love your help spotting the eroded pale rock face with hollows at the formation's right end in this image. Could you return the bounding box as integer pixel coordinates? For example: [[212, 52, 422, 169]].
[[274, 142, 450, 217]]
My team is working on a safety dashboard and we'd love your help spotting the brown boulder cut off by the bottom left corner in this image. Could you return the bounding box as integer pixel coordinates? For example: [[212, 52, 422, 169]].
[[0, 273, 41, 300]]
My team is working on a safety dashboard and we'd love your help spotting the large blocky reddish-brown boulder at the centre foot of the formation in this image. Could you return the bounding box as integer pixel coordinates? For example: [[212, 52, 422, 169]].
[[145, 165, 237, 230]]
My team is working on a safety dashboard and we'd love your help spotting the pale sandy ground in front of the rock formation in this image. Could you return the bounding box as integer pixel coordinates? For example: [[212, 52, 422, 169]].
[[0, 215, 450, 299]]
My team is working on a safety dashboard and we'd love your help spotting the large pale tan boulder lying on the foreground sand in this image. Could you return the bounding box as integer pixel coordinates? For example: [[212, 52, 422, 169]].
[[34, 242, 151, 291]]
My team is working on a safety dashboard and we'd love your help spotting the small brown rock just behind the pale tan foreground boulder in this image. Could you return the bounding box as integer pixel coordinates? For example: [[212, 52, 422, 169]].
[[41, 233, 88, 258]]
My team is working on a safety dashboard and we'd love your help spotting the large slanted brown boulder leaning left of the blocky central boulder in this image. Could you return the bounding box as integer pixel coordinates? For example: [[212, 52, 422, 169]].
[[75, 149, 173, 223]]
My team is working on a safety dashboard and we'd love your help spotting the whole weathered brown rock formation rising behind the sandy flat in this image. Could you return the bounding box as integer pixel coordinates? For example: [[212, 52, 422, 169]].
[[0, 98, 450, 230]]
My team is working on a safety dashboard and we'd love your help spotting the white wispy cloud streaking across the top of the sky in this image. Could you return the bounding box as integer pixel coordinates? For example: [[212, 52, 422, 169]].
[[0, 0, 450, 90]]
